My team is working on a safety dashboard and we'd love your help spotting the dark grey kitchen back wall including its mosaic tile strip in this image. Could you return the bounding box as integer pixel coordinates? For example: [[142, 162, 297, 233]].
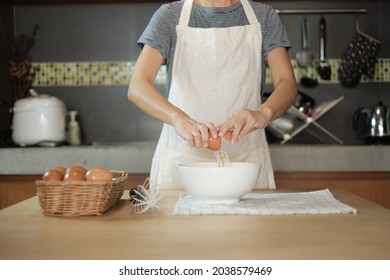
[[0, 0, 390, 145]]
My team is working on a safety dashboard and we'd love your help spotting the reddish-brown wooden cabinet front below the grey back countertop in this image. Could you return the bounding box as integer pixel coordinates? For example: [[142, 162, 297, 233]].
[[0, 172, 390, 209]]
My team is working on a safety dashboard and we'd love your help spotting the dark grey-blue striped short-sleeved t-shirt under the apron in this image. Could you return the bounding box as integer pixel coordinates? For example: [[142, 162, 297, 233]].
[[138, 0, 290, 92]]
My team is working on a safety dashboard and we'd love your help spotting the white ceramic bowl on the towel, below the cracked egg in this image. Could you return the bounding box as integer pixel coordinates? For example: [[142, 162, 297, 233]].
[[177, 162, 260, 204]]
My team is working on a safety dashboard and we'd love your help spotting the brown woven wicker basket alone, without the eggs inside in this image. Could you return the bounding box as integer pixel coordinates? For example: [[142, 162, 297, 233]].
[[35, 170, 128, 216]]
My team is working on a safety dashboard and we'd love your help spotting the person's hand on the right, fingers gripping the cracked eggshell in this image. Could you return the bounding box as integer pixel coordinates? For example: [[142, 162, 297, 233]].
[[218, 107, 272, 144]]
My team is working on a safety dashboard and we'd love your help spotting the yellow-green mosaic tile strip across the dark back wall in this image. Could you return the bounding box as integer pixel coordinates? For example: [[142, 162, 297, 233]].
[[34, 58, 390, 87]]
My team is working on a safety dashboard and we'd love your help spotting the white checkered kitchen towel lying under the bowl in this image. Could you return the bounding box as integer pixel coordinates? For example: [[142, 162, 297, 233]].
[[173, 189, 357, 215]]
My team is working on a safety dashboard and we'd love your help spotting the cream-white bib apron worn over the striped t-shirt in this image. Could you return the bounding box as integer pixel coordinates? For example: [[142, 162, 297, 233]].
[[150, 0, 275, 189]]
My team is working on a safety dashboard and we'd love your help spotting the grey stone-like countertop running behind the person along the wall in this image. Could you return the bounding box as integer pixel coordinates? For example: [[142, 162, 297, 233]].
[[0, 142, 390, 175]]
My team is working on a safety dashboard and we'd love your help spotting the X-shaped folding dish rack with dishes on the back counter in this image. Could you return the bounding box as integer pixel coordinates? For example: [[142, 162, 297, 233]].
[[268, 95, 345, 145]]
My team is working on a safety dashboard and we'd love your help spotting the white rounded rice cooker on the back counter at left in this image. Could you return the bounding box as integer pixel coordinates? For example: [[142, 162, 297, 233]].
[[12, 94, 67, 146]]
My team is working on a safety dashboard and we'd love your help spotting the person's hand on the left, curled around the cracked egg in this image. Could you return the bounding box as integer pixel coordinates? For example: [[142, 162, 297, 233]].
[[173, 116, 218, 148]]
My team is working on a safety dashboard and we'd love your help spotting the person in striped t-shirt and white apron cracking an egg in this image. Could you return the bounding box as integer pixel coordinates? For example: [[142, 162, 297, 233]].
[[128, 0, 297, 188]]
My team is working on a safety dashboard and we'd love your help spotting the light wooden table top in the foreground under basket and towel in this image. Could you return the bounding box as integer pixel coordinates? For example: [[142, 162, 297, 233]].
[[0, 189, 390, 260]]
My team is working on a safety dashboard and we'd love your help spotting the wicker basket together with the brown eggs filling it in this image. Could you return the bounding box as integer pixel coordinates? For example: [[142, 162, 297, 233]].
[[35, 166, 128, 216]]
